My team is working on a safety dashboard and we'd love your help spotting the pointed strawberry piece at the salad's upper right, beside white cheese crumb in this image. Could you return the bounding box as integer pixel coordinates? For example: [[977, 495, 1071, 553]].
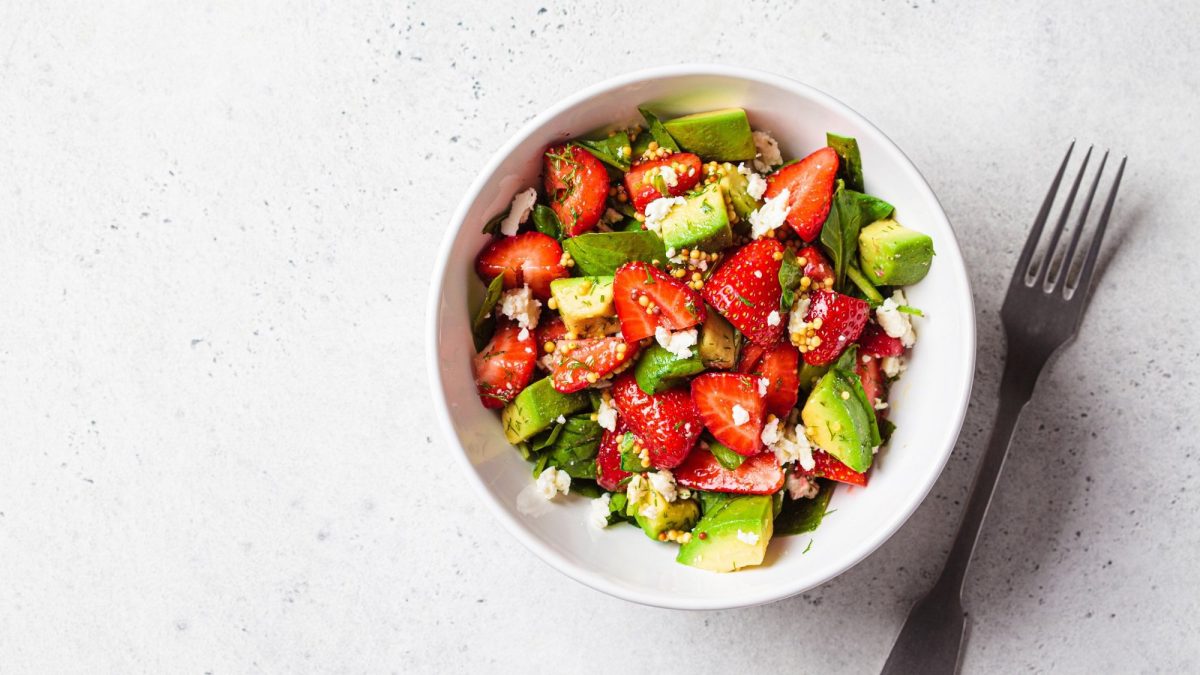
[[763, 148, 838, 241]]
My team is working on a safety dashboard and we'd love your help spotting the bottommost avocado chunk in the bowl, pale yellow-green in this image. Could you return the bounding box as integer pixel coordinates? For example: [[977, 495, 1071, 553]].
[[676, 495, 775, 572]]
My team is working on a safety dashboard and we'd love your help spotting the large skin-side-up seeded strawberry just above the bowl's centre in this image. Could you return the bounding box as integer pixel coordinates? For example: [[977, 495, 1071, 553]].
[[704, 239, 787, 345]]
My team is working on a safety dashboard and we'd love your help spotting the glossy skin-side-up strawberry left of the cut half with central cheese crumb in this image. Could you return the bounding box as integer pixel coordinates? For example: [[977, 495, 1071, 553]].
[[612, 372, 704, 468]]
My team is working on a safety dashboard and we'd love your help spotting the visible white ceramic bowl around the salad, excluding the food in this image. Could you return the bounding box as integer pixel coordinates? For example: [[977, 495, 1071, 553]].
[[427, 65, 976, 609]]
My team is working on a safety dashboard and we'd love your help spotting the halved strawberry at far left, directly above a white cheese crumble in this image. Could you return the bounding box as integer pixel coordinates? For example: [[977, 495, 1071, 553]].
[[475, 232, 566, 300]]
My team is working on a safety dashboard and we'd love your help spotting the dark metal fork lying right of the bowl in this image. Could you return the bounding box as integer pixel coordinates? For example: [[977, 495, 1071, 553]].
[[883, 142, 1126, 675]]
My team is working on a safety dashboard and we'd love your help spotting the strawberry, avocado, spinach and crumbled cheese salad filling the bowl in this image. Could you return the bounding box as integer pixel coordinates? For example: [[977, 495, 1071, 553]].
[[470, 103, 934, 572]]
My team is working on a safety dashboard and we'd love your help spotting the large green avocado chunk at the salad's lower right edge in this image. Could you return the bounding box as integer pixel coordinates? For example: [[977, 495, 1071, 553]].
[[800, 369, 878, 472]]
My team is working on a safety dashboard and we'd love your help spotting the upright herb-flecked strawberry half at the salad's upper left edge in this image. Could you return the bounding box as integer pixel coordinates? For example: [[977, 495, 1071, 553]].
[[542, 144, 608, 237]]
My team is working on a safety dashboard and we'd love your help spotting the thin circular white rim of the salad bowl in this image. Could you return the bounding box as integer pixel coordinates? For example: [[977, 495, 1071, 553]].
[[425, 64, 977, 610]]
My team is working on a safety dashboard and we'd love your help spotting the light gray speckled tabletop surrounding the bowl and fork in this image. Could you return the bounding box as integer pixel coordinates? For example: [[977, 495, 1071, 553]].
[[0, 0, 1200, 673]]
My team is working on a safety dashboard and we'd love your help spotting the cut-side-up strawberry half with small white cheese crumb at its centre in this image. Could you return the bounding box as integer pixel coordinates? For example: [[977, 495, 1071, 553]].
[[691, 372, 766, 456]]
